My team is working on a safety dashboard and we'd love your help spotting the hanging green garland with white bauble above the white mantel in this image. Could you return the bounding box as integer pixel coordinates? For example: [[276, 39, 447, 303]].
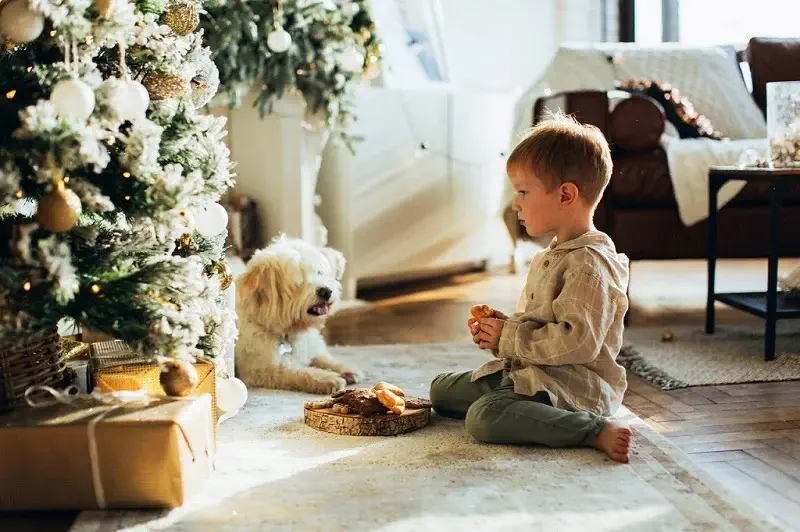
[[201, 0, 383, 149]]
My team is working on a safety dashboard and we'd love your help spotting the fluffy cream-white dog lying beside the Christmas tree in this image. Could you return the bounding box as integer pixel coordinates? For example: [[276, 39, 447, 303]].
[[236, 236, 361, 394]]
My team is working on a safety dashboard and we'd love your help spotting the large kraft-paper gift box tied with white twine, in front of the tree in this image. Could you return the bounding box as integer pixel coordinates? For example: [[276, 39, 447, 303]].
[[0, 389, 214, 510]]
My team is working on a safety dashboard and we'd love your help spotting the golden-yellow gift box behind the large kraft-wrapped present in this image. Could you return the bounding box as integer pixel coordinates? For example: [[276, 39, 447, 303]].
[[89, 341, 222, 442]]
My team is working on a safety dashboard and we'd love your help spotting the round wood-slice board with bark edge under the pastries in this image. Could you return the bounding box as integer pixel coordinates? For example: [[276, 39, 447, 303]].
[[304, 407, 431, 436]]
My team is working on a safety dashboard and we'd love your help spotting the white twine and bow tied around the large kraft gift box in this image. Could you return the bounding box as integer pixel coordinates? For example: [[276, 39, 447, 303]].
[[25, 386, 210, 509]]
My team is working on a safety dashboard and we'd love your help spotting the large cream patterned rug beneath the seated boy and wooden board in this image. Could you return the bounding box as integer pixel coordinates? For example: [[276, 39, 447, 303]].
[[73, 344, 778, 532]]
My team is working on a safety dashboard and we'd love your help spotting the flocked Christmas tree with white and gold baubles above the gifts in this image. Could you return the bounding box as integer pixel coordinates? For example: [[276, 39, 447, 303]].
[[0, 0, 236, 372]]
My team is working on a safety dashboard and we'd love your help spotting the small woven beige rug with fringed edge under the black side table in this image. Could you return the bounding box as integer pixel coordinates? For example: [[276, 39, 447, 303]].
[[617, 321, 800, 390]]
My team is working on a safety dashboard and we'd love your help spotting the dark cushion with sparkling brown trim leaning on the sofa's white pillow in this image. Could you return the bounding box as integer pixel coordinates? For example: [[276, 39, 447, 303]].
[[617, 79, 727, 140]]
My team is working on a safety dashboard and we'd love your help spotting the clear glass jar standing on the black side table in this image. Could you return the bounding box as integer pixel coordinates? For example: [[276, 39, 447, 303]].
[[767, 81, 800, 168]]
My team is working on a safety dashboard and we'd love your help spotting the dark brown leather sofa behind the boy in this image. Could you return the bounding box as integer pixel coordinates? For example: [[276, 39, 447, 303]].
[[506, 38, 800, 259]]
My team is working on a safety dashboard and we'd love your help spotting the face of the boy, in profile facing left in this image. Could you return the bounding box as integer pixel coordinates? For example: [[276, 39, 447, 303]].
[[509, 170, 563, 238]]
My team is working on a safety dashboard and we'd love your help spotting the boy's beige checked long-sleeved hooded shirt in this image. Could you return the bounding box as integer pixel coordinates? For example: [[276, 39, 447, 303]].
[[472, 230, 629, 416]]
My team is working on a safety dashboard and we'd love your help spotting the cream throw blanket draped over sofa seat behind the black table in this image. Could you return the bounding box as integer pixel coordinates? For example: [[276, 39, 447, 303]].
[[661, 135, 767, 226]]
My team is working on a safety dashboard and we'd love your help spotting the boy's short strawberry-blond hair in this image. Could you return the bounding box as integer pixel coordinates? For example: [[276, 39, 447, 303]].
[[506, 112, 612, 207]]
